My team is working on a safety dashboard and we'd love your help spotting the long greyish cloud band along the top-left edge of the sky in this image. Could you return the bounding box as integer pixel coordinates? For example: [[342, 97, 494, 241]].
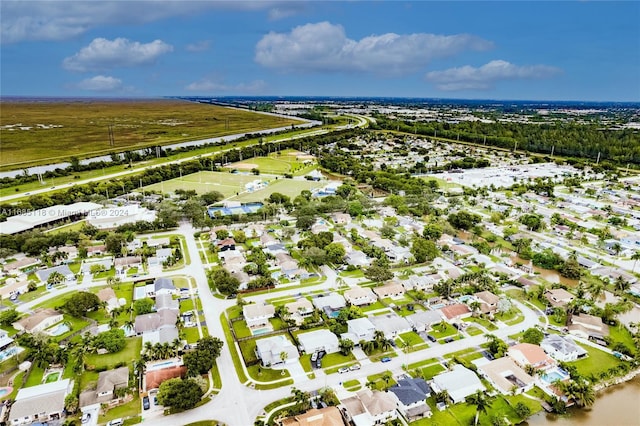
[[0, 0, 300, 44]]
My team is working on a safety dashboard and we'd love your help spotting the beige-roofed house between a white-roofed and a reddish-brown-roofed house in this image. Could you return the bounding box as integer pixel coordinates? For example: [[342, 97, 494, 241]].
[[478, 357, 535, 395]]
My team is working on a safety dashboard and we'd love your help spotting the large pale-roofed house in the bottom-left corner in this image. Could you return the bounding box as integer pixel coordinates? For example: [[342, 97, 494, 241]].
[[8, 379, 73, 425]]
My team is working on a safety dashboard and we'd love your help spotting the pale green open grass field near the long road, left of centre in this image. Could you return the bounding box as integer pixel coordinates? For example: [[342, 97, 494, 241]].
[[145, 171, 270, 200]]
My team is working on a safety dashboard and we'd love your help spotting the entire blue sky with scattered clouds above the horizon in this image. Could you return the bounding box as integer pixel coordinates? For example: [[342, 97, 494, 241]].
[[0, 0, 640, 101]]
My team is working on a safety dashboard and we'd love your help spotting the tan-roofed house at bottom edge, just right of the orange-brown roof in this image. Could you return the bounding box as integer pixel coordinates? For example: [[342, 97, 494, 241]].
[[340, 388, 398, 426]]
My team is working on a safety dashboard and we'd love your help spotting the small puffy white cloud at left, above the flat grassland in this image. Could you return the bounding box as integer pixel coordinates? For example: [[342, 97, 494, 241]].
[[62, 38, 173, 72]]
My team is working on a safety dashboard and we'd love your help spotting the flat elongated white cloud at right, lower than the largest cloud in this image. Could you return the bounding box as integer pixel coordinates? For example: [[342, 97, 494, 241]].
[[425, 60, 562, 91]]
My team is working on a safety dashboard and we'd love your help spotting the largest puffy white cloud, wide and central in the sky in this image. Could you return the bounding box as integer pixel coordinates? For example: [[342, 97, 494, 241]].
[[255, 22, 493, 74]]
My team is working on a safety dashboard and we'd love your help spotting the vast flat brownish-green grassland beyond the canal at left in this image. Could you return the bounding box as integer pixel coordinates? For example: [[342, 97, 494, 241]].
[[0, 99, 298, 168]]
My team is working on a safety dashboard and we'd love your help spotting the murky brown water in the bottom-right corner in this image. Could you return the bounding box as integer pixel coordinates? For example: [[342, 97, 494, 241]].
[[526, 375, 640, 426]]
